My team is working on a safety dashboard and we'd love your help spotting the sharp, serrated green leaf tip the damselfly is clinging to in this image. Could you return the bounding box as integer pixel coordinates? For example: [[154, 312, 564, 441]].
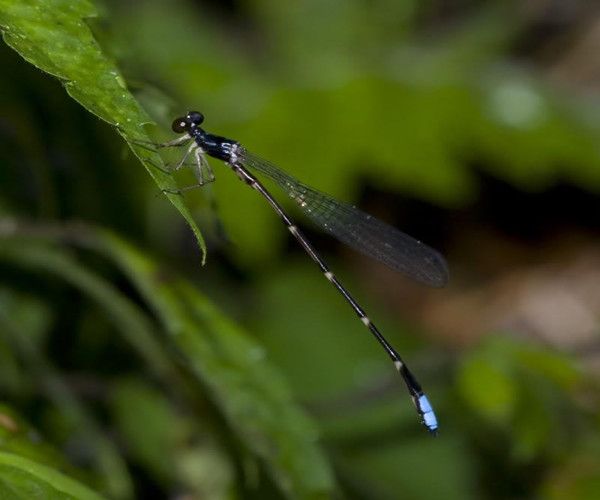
[[0, 0, 206, 261]]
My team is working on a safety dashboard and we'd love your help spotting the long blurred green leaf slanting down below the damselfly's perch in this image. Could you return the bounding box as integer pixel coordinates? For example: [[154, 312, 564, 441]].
[[98, 232, 333, 498]]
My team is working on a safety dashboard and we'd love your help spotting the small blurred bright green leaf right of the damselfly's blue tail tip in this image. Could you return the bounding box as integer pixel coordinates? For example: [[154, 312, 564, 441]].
[[458, 336, 582, 444]]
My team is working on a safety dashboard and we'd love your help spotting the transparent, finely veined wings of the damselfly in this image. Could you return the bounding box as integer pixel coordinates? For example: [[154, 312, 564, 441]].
[[238, 148, 448, 287]]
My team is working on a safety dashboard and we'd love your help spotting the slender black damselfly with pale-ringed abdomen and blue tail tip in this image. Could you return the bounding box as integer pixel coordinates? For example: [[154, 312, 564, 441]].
[[145, 111, 448, 433]]
